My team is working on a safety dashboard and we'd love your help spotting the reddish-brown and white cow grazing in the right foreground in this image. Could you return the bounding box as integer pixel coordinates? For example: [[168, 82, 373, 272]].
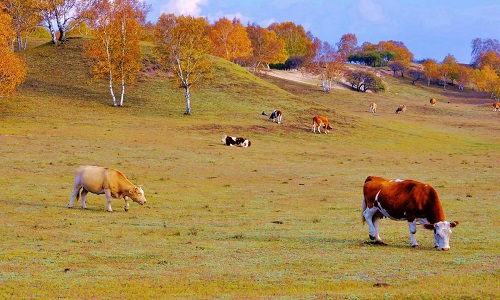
[[363, 176, 458, 250]]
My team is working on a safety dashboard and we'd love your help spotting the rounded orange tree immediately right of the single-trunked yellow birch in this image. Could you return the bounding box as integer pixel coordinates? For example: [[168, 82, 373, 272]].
[[210, 18, 252, 62]]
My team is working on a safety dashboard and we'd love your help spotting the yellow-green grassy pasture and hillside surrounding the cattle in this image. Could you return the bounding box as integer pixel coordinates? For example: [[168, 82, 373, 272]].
[[0, 39, 500, 299]]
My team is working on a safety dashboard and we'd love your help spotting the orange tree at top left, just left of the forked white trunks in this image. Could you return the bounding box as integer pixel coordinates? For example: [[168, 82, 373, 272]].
[[4, 0, 42, 51]]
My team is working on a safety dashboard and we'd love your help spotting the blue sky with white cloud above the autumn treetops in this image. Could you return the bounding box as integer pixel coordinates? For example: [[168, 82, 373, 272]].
[[145, 0, 500, 63]]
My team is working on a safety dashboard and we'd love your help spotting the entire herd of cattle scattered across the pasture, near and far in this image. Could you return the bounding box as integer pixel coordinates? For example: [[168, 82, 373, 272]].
[[68, 98, 500, 251]]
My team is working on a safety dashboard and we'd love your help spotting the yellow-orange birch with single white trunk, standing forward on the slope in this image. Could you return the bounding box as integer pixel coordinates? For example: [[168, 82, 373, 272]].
[[154, 14, 214, 115]]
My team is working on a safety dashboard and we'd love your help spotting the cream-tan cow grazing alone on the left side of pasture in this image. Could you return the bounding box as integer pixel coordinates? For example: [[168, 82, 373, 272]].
[[68, 166, 146, 212]]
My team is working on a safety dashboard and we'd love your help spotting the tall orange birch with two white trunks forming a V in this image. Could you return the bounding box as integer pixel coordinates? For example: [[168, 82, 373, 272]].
[[86, 0, 147, 106]]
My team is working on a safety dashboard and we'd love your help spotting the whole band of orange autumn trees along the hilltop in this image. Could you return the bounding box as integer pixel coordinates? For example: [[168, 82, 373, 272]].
[[0, 0, 500, 109]]
